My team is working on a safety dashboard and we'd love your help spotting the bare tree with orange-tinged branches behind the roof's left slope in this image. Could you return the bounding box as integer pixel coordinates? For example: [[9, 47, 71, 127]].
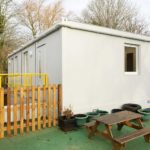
[[18, 0, 64, 38]]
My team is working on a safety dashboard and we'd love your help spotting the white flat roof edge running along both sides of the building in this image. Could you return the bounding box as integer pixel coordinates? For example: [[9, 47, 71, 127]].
[[8, 21, 150, 57]]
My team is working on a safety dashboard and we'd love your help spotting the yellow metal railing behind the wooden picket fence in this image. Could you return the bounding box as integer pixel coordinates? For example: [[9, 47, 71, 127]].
[[0, 73, 48, 88]]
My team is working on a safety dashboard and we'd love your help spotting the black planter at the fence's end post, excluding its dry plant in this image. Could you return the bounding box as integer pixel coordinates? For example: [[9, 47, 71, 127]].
[[58, 116, 76, 132]]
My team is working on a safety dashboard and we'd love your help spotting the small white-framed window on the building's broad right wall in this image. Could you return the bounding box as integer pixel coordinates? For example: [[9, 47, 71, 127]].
[[124, 45, 138, 73]]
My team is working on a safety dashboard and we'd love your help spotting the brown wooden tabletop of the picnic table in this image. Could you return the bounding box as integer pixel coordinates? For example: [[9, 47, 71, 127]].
[[96, 111, 142, 125]]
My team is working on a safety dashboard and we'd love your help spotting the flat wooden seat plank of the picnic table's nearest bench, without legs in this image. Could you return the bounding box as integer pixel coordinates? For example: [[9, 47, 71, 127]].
[[115, 128, 150, 144]]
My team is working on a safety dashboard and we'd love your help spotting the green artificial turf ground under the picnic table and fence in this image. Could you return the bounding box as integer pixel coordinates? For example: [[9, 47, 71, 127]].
[[0, 123, 150, 150]]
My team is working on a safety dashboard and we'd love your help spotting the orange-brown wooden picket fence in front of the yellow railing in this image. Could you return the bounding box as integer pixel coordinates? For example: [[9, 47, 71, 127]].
[[0, 85, 62, 139]]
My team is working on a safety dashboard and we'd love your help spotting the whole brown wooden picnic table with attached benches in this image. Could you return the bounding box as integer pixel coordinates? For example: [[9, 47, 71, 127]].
[[85, 111, 150, 150]]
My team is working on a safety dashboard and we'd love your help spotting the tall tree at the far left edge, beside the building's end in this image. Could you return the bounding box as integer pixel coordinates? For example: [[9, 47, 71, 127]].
[[0, 0, 20, 73]]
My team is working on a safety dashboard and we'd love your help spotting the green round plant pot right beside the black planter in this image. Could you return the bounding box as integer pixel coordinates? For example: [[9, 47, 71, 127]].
[[75, 114, 88, 127]]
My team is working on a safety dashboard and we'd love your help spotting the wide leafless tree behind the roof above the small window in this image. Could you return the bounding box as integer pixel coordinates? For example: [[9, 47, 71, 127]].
[[80, 0, 148, 34]]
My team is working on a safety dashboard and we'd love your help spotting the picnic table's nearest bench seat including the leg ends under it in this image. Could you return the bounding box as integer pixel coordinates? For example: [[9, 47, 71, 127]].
[[114, 128, 150, 150]]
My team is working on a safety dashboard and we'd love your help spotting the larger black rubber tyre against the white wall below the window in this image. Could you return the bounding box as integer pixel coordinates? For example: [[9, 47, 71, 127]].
[[122, 104, 142, 112]]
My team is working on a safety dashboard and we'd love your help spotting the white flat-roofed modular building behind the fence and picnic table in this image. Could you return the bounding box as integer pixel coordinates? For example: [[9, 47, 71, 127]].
[[8, 21, 150, 113]]
